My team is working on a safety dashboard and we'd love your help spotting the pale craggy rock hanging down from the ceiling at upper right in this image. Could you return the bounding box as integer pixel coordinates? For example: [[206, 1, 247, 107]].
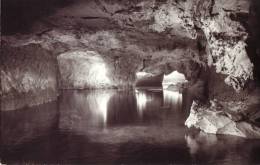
[[149, 0, 253, 91]]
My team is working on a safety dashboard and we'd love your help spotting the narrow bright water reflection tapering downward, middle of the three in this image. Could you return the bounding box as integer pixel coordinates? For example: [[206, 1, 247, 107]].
[[135, 89, 152, 115]]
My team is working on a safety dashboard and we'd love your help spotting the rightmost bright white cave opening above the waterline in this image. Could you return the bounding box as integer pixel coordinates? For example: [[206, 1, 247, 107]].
[[162, 71, 187, 89]]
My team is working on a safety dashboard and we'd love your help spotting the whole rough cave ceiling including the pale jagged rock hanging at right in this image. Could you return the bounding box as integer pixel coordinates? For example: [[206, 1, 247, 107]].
[[2, 0, 258, 90]]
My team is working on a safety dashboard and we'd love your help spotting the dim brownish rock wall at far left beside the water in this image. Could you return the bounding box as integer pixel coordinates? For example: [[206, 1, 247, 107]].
[[0, 43, 58, 110]]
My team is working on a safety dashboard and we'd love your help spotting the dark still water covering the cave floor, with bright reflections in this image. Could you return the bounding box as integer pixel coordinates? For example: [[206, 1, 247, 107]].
[[1, 89, 260, 165]]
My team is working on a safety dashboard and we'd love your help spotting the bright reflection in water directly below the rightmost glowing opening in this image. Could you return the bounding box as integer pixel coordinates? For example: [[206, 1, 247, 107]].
[[163, 90, 182, 105]]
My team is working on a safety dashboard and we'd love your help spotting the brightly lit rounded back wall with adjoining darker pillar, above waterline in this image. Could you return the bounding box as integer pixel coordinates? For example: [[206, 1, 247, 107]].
[[57, 50, 142, 89]]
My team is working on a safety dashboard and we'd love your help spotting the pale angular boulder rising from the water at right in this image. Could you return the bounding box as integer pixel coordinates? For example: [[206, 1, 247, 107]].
[[185, 101, 260, 138]]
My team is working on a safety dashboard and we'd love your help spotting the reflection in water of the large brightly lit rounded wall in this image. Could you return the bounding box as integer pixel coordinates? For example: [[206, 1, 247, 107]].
[[59, 90, 114, 130]]
